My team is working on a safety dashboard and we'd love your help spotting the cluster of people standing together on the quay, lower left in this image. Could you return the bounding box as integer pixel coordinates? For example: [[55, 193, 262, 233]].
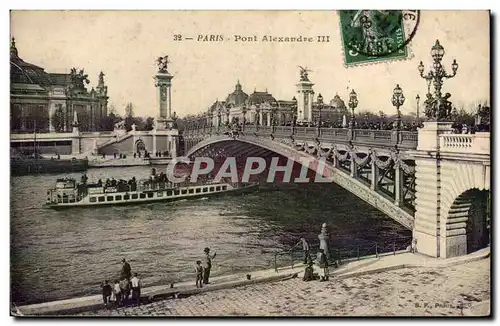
[[101, 258, 142, 308]]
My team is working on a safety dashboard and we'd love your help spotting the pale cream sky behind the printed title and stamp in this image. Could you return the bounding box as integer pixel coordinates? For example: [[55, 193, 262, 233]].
[[10, 11, 490, 116]]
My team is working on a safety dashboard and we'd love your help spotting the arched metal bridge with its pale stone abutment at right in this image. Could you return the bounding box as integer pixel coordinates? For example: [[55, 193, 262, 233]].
[[183, 121, 491, 258]]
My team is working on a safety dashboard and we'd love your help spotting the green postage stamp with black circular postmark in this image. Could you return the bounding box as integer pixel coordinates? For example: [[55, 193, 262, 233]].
[[339, 10, 420, 66]]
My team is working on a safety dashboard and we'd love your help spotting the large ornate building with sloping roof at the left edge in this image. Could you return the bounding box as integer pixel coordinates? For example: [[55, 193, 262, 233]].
[[10, 38, 108, 133]]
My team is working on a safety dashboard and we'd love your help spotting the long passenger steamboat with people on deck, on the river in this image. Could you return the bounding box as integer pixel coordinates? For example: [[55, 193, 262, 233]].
[[45, 171, 258, 209]]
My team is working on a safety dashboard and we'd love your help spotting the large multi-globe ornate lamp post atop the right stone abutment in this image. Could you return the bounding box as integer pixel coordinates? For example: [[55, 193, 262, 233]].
[[418, 40, 458, 121]]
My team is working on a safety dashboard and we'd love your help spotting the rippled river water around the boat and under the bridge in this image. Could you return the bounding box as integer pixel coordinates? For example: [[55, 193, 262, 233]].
[[10, 167, 411, 304]]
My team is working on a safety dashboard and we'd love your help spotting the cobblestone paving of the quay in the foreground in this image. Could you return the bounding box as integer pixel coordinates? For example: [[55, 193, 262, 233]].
[[81, 259, 490, 316]]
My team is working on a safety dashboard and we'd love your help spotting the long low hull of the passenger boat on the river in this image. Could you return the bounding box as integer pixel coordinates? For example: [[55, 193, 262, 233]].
[[45, 184, 259, 210]]
